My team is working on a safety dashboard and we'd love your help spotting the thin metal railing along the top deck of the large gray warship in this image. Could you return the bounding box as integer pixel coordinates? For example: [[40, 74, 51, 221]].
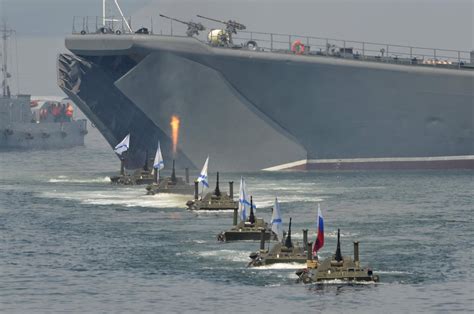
[[72, 16, 474, 69]]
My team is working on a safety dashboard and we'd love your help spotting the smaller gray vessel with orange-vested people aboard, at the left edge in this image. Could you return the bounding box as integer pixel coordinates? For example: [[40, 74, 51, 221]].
[[0, 23, 87, 151]]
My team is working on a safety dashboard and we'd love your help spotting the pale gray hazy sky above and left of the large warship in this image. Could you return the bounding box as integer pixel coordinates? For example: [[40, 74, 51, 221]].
[[0, 0, 474, 95]]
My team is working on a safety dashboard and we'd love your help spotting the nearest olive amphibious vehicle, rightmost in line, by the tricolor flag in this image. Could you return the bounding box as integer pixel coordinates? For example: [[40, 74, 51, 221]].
[[296, 229, 380, 283]]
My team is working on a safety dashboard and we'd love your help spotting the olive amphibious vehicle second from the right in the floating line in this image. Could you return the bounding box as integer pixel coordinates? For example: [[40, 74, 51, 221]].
[[248, 218, 308, 267]]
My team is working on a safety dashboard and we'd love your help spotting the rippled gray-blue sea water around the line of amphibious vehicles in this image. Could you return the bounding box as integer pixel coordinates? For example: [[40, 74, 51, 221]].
[[0, 130, 474, 313]]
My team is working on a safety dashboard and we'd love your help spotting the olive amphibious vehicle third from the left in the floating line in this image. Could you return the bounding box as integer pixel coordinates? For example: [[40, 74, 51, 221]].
[[186, 172, 238, 210]]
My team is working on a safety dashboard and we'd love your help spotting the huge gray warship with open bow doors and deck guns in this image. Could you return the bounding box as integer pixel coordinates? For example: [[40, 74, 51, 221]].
[[58, 2, 474, 171]]
